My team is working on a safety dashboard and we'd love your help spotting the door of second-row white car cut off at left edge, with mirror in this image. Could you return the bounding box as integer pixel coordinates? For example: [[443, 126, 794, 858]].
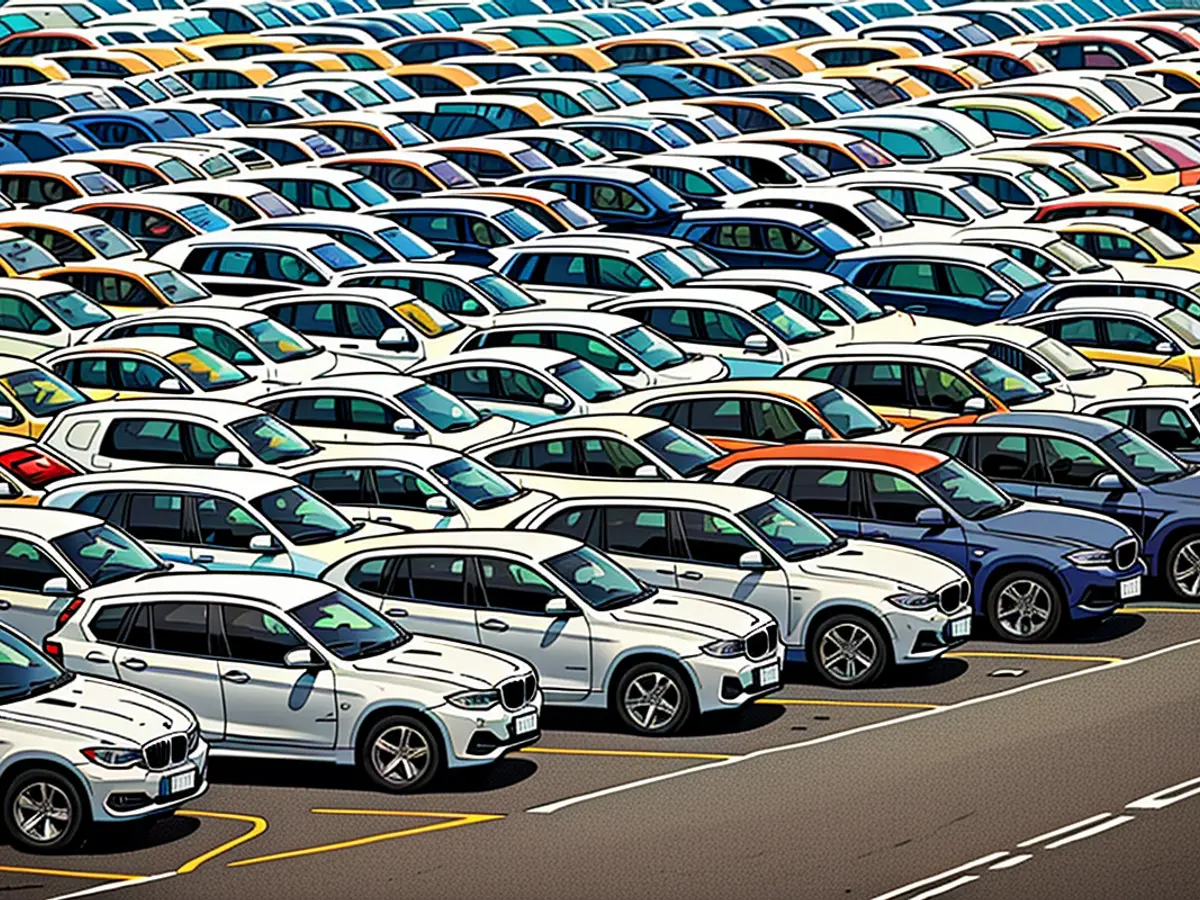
[[0, 536, 75, 644]]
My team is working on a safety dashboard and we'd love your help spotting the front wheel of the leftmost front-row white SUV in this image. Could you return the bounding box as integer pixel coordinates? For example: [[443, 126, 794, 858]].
[[4, 769, 89, 853]]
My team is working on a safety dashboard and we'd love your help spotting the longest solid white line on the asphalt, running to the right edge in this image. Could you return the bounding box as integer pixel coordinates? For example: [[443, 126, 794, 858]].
[[526, 638, 1200, 814]]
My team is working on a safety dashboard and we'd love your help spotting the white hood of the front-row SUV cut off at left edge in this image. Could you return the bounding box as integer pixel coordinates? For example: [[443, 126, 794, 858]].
[[0, 676, 196, 746]]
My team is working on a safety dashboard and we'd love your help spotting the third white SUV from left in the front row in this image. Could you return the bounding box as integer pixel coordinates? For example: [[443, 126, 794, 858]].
[[322, 530, 782, 736]]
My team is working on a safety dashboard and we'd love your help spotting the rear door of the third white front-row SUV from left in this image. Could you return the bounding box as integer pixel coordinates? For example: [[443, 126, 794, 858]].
[[380, 553, 480, 644]]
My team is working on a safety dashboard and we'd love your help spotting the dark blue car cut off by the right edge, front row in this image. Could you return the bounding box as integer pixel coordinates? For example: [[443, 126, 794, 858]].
[[910, 413, 1200, 601]]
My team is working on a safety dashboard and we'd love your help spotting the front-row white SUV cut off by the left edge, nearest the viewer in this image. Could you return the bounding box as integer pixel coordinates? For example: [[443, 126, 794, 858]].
[[0, 625, 209, 853]]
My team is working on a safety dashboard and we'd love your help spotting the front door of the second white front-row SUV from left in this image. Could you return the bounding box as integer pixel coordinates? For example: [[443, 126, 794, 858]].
[[212, 604, 337, 751]]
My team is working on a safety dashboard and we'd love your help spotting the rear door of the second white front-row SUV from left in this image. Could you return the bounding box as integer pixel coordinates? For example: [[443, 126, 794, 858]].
[[112, 601, 226, 740]]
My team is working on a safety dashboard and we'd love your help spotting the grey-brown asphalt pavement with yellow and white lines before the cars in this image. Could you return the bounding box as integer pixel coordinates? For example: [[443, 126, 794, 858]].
[[7, 606, 1200, 900]]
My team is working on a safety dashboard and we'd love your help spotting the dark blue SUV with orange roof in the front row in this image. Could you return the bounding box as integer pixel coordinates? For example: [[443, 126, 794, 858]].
[[713, 442, 1146, 642]]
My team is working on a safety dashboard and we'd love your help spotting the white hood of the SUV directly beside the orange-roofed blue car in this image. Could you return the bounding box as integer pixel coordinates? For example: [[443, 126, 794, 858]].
[[793, 540, 964, 594]]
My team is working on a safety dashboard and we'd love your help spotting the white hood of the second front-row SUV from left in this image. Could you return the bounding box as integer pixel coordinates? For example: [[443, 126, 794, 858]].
[[348, 635, 532, 694]]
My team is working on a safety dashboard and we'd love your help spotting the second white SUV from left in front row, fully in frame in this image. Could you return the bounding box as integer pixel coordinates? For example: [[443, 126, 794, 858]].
[[49, 574, 541, 791]]
